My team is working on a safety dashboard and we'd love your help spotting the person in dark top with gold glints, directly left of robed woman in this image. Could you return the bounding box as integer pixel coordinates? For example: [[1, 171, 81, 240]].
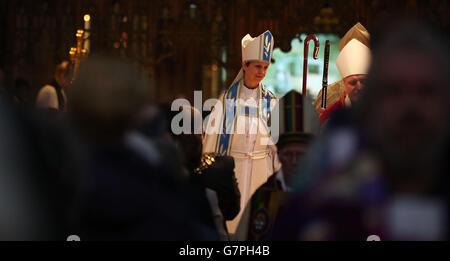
[[172, 106, 240, 240]]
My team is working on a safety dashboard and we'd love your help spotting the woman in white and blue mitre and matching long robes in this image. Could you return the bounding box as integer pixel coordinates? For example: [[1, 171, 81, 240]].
[[203, 31, 281, 240]]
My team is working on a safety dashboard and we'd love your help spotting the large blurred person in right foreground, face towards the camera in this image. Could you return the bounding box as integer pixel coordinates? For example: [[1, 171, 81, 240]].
[[276, 22, 450, 241]]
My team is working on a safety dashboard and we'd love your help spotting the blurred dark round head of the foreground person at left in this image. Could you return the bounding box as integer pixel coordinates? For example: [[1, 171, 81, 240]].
[[68, 54, 148, 140]]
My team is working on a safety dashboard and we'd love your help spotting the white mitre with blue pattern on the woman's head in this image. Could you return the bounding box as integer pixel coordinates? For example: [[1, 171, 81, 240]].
[[231, 30, 275, 86]]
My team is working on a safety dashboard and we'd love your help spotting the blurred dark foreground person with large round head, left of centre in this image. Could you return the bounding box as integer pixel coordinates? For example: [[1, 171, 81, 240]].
[[68, 56, 211, 240]]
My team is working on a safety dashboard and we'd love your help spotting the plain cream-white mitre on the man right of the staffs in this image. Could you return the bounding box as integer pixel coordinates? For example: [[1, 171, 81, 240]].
[[336, 39, 371, 79]]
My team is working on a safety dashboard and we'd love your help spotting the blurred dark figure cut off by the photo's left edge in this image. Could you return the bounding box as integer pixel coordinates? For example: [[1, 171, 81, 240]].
[[0, 77, 80, 241]]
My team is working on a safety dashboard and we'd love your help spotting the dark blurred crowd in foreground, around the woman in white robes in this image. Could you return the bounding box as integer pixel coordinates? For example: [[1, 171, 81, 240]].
[[0, 22, 450, 241]]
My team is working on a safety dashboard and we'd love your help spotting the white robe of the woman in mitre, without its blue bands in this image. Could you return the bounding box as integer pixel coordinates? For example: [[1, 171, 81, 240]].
[[203, 79, 281, 240]]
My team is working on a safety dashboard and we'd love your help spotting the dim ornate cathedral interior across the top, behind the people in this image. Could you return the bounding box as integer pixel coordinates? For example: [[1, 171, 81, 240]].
[[0, 0, 450, 102]]
